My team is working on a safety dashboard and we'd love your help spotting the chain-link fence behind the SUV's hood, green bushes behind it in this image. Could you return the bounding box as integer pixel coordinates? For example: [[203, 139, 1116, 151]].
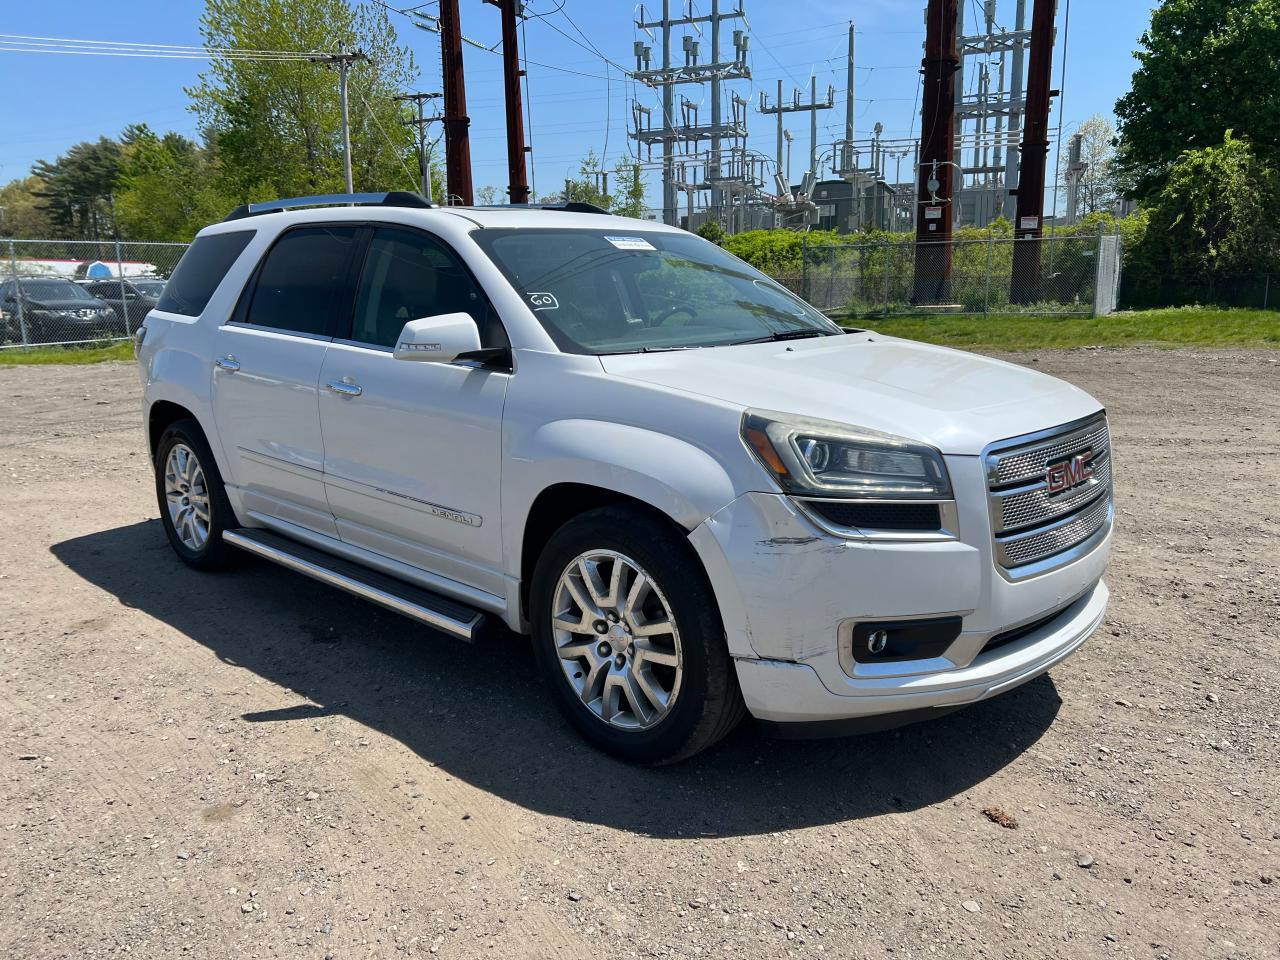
[[776, 237, 1120, 316]]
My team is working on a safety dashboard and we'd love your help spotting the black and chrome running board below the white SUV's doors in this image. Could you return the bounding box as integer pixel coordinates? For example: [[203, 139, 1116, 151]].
[[223, 527, 485, 643]]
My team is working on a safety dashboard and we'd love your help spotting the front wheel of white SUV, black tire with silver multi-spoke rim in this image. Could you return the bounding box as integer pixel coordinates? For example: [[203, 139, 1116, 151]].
[[530, 507, 745, 764]]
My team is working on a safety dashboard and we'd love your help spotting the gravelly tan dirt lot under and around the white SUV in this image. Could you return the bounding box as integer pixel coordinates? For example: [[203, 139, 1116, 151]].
[[0, 351, 1280, 960]]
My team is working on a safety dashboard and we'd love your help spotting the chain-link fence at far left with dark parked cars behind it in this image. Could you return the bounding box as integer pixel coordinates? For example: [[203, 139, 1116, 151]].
[[0, 239, 187, 349]]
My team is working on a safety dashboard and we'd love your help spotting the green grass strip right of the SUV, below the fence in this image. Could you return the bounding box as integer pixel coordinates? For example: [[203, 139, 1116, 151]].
[[840, 307, 1280, 351]]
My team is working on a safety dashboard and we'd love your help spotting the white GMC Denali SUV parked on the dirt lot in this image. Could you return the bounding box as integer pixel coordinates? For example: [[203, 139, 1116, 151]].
[[138, 193, 1114, 763]]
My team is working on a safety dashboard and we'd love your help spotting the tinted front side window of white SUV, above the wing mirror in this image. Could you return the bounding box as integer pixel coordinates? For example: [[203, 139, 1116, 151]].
[[351, 228, 500, 347]]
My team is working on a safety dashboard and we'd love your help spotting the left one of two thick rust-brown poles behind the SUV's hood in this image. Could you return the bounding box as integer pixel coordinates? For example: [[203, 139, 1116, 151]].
[[913, 0, 960, 303]]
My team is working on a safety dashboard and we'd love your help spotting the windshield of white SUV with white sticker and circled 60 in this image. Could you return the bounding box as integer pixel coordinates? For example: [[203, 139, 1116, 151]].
[[471, 229, 841, 355]]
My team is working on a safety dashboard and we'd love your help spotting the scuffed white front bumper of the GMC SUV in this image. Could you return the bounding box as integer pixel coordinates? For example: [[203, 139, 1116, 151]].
[[690, 457, 1111, 724]]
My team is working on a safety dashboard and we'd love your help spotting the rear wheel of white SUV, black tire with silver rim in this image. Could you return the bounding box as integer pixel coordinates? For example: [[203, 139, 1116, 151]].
[[154, 420, 238, 570]]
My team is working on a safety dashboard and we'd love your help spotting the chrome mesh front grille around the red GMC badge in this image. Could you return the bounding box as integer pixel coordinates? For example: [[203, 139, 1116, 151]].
[[986, 415, 1112, 576]]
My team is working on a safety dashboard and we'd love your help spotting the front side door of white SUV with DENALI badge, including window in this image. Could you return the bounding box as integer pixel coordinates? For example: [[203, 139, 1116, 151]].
[[320, 228, 509, 596]]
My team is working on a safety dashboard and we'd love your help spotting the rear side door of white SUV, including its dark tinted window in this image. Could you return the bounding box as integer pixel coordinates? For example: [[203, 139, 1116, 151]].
[[212, 224, 362, 536]]
